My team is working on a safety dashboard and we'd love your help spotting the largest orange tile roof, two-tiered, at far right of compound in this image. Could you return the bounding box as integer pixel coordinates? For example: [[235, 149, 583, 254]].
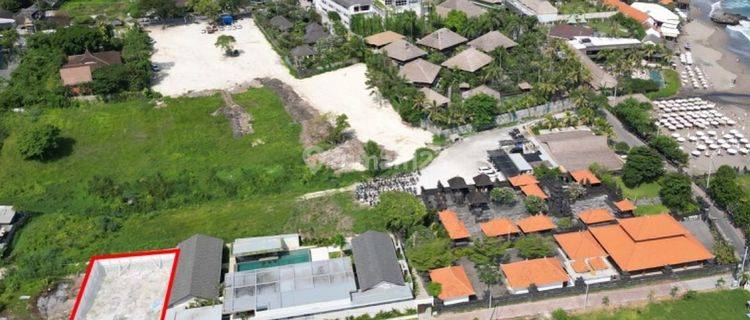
[[589, 215, 714, 271]]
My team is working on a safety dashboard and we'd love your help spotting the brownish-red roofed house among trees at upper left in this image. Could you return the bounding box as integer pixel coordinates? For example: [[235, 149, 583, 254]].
[[60, 50, 122, 94]]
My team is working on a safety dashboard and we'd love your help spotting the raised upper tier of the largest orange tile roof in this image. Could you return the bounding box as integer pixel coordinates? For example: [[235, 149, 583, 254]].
[[618, 213, 688, 241]]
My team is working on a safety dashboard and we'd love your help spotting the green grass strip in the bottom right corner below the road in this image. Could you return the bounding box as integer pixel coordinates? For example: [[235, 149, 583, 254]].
[[574, 289, 750, 320]]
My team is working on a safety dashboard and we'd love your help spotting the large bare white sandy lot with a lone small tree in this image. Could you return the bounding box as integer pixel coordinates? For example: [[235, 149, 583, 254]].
[[148, 19, 432, 164]]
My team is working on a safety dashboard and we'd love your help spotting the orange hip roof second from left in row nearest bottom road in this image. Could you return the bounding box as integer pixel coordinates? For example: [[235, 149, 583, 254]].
[[500, 258, 570, 289]]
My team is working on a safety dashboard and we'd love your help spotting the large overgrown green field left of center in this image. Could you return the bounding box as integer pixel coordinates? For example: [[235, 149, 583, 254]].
[[0, 89, 374, 319]]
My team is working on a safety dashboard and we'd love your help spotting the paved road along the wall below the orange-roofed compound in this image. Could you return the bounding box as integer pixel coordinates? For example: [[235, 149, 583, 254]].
[[435, 274, 732, 320]]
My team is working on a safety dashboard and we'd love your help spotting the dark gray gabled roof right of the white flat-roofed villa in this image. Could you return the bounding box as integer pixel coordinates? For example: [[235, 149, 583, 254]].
[[352, 231, 404, 291]]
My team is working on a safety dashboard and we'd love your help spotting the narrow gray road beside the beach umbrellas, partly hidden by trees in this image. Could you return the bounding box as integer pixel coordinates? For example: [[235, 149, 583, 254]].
[[603, 104, 745, 258]]
